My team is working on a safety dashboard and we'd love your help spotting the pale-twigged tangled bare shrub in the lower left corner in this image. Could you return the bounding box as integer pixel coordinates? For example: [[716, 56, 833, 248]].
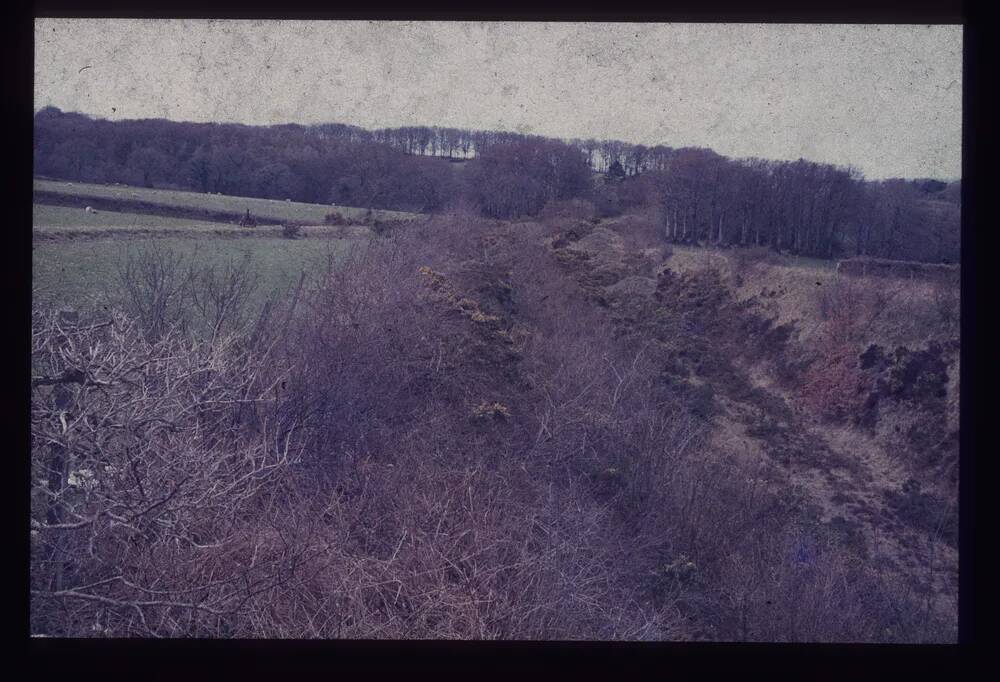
[[31, 306, 310, 636]]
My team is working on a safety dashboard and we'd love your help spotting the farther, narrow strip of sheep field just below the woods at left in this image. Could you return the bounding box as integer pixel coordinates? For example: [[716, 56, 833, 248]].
[[34, 178, 413, 224]]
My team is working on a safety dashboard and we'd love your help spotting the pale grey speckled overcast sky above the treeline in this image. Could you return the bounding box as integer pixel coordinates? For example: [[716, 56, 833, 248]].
[[34, 19, 962, 180]]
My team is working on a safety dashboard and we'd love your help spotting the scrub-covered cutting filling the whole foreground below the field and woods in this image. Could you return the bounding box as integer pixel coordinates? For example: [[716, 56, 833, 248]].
[[32, 202, 959, 642]]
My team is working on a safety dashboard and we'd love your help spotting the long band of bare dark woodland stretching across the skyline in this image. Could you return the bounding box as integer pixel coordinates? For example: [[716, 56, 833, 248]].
[[34, 107, 961, 263]]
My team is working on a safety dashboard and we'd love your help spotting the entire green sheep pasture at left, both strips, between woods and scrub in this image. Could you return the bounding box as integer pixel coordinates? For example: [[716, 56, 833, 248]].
[[32, 179, 388, 308]]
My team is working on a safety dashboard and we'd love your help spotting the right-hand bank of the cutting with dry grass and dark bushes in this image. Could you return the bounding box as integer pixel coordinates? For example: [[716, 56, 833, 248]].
[[550, 215, 958, 623]]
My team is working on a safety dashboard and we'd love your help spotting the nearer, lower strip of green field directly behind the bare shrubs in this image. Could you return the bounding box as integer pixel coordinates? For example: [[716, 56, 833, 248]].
[[32, 237, 365, 309]]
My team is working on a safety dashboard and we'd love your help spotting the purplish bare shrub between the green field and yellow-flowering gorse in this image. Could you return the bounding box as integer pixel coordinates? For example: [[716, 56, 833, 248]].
[[276, 228, 455, 456]]
